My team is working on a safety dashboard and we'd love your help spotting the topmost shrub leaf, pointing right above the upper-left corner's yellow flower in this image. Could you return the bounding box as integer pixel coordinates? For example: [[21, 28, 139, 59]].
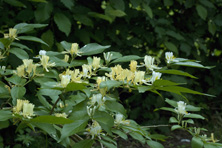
[[14, 23, 48, 34]]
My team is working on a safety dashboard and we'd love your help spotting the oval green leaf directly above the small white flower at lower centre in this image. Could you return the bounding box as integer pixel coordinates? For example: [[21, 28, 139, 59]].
[[105, 100, 126, 116]]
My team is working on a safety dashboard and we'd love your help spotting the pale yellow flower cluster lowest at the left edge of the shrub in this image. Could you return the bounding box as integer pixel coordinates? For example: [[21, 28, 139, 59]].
[[13, 99, 35, 118]]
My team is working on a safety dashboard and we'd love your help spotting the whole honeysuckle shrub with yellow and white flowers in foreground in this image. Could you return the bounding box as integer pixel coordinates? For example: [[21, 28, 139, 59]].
[[0, 23, 222, 148]]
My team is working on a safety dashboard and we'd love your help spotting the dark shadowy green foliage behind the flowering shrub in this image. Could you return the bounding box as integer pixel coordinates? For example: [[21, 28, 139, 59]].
[[0, 0, 222, 147]]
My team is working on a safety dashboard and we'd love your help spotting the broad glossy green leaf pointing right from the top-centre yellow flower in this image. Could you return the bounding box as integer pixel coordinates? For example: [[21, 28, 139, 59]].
[[79, 43, 110, 56]]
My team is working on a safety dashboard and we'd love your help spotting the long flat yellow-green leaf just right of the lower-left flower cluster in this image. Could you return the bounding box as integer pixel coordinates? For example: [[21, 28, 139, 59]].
[[30, 115, 74, 124]]
